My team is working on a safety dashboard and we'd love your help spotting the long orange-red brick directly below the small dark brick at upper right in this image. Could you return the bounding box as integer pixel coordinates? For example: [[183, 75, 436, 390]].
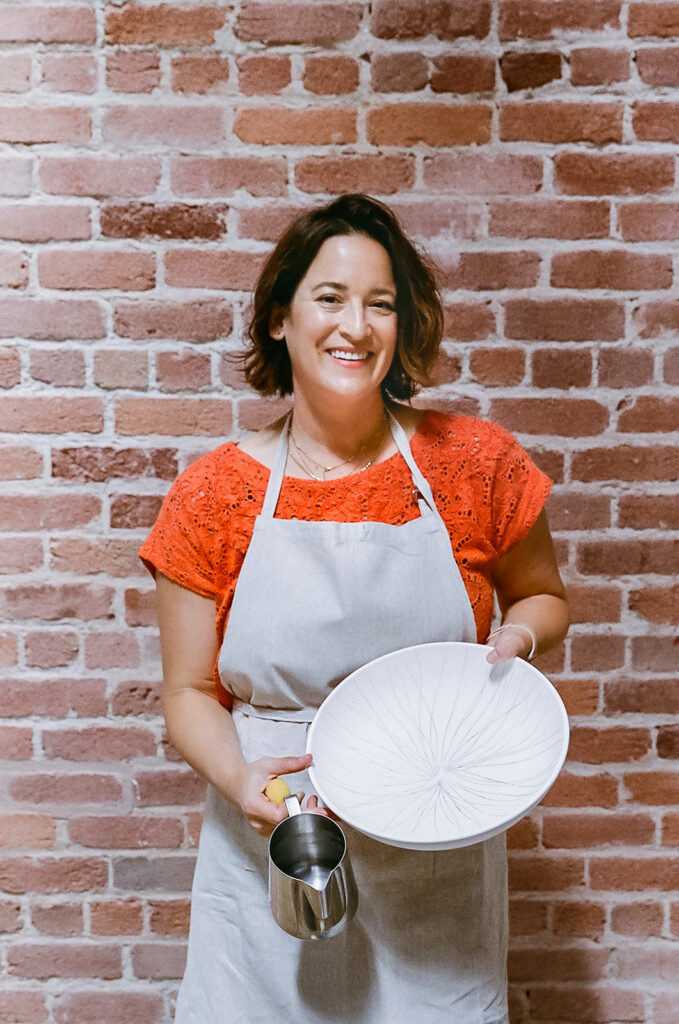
[[500, 102, 623, 144]]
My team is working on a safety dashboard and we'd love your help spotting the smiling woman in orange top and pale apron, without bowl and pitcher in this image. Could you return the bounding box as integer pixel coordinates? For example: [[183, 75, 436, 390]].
[[141, 196, 567, 1024]]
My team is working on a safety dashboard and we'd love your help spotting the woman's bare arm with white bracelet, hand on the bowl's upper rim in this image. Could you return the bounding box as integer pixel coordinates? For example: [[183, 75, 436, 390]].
[[487, 512, 568, 662]]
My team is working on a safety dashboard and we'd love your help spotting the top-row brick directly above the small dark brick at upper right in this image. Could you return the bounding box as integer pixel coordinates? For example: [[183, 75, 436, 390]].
[[499, 0, 621, 40]]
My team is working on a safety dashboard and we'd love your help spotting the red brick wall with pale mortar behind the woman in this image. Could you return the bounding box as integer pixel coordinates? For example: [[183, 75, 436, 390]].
[[0, 0, 679, 1024]]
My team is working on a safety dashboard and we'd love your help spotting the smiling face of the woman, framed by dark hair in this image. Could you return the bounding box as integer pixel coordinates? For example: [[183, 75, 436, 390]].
[[271, 234, 396, 398]]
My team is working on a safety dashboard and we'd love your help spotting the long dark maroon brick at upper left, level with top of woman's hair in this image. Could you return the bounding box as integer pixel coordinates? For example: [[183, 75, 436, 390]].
[[101, 203, 228, 241]]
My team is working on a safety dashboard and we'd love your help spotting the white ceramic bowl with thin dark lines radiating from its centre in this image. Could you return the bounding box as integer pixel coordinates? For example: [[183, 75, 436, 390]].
[[306, 643, 568, 850]]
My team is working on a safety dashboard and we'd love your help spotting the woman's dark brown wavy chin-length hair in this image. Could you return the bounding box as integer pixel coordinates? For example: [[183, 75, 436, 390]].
[[240, 194, 443, 399]]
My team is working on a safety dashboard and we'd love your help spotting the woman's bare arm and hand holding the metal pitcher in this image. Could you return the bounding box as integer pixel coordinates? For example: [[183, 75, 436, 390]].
[[156, 572, 311, 835]]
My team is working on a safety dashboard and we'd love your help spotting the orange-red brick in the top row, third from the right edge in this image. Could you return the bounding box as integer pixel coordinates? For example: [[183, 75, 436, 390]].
[[371, 0, 491, 40]]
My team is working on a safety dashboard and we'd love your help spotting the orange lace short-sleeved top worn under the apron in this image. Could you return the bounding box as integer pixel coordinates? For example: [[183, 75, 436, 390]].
[[139, 412, 551, 702]]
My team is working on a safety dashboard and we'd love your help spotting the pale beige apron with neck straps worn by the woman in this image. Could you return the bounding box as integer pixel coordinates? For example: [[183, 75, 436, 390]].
[[176, 418, 507, 1024]]
